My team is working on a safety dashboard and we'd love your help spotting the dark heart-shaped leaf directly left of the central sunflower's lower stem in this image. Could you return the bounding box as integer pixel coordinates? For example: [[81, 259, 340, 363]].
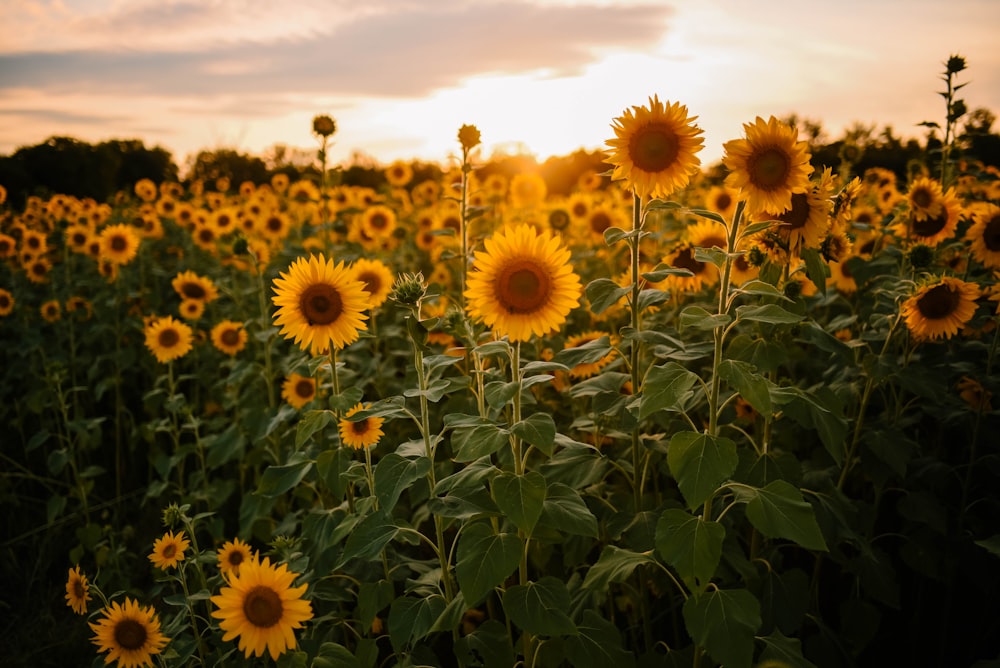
[[455, 522, 524, 608]]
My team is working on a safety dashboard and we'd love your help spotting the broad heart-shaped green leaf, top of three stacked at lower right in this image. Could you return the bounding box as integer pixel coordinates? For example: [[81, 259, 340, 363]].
[[667, 431, 739, 510]]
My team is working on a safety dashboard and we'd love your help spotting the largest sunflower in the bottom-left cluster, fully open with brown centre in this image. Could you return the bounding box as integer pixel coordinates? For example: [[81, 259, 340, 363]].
[[211, 557, 313, 660]]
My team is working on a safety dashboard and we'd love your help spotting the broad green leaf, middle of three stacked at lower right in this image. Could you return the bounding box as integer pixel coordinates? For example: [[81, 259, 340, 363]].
[[656, 508, 726, 590]]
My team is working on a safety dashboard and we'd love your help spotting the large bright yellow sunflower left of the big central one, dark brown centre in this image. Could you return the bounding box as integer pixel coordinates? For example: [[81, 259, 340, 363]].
[[272, 254, 369, 355]]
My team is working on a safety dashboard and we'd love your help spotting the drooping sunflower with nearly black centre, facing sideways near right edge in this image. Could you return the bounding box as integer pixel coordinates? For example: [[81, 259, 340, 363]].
[[902, 276, 979, 340]]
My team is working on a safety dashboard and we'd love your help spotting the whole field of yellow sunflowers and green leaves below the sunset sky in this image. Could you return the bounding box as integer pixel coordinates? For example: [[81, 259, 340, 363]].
[[0, 56, 1000, 668]]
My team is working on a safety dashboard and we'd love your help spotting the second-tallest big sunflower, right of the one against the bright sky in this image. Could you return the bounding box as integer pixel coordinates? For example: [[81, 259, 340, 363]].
[[722, 116, 813, 214]]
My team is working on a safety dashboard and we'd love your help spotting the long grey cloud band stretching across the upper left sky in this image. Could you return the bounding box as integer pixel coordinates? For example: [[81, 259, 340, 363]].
[[0, 0, 671, 102]]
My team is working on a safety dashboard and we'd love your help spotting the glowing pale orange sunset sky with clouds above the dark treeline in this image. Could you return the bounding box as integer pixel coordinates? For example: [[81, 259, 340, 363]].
[[0, 0, 1000, 174]]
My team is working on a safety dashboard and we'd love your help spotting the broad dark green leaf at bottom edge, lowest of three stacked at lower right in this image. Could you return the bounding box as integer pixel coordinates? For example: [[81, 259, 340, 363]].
[[683, 589, 760, 668]]
